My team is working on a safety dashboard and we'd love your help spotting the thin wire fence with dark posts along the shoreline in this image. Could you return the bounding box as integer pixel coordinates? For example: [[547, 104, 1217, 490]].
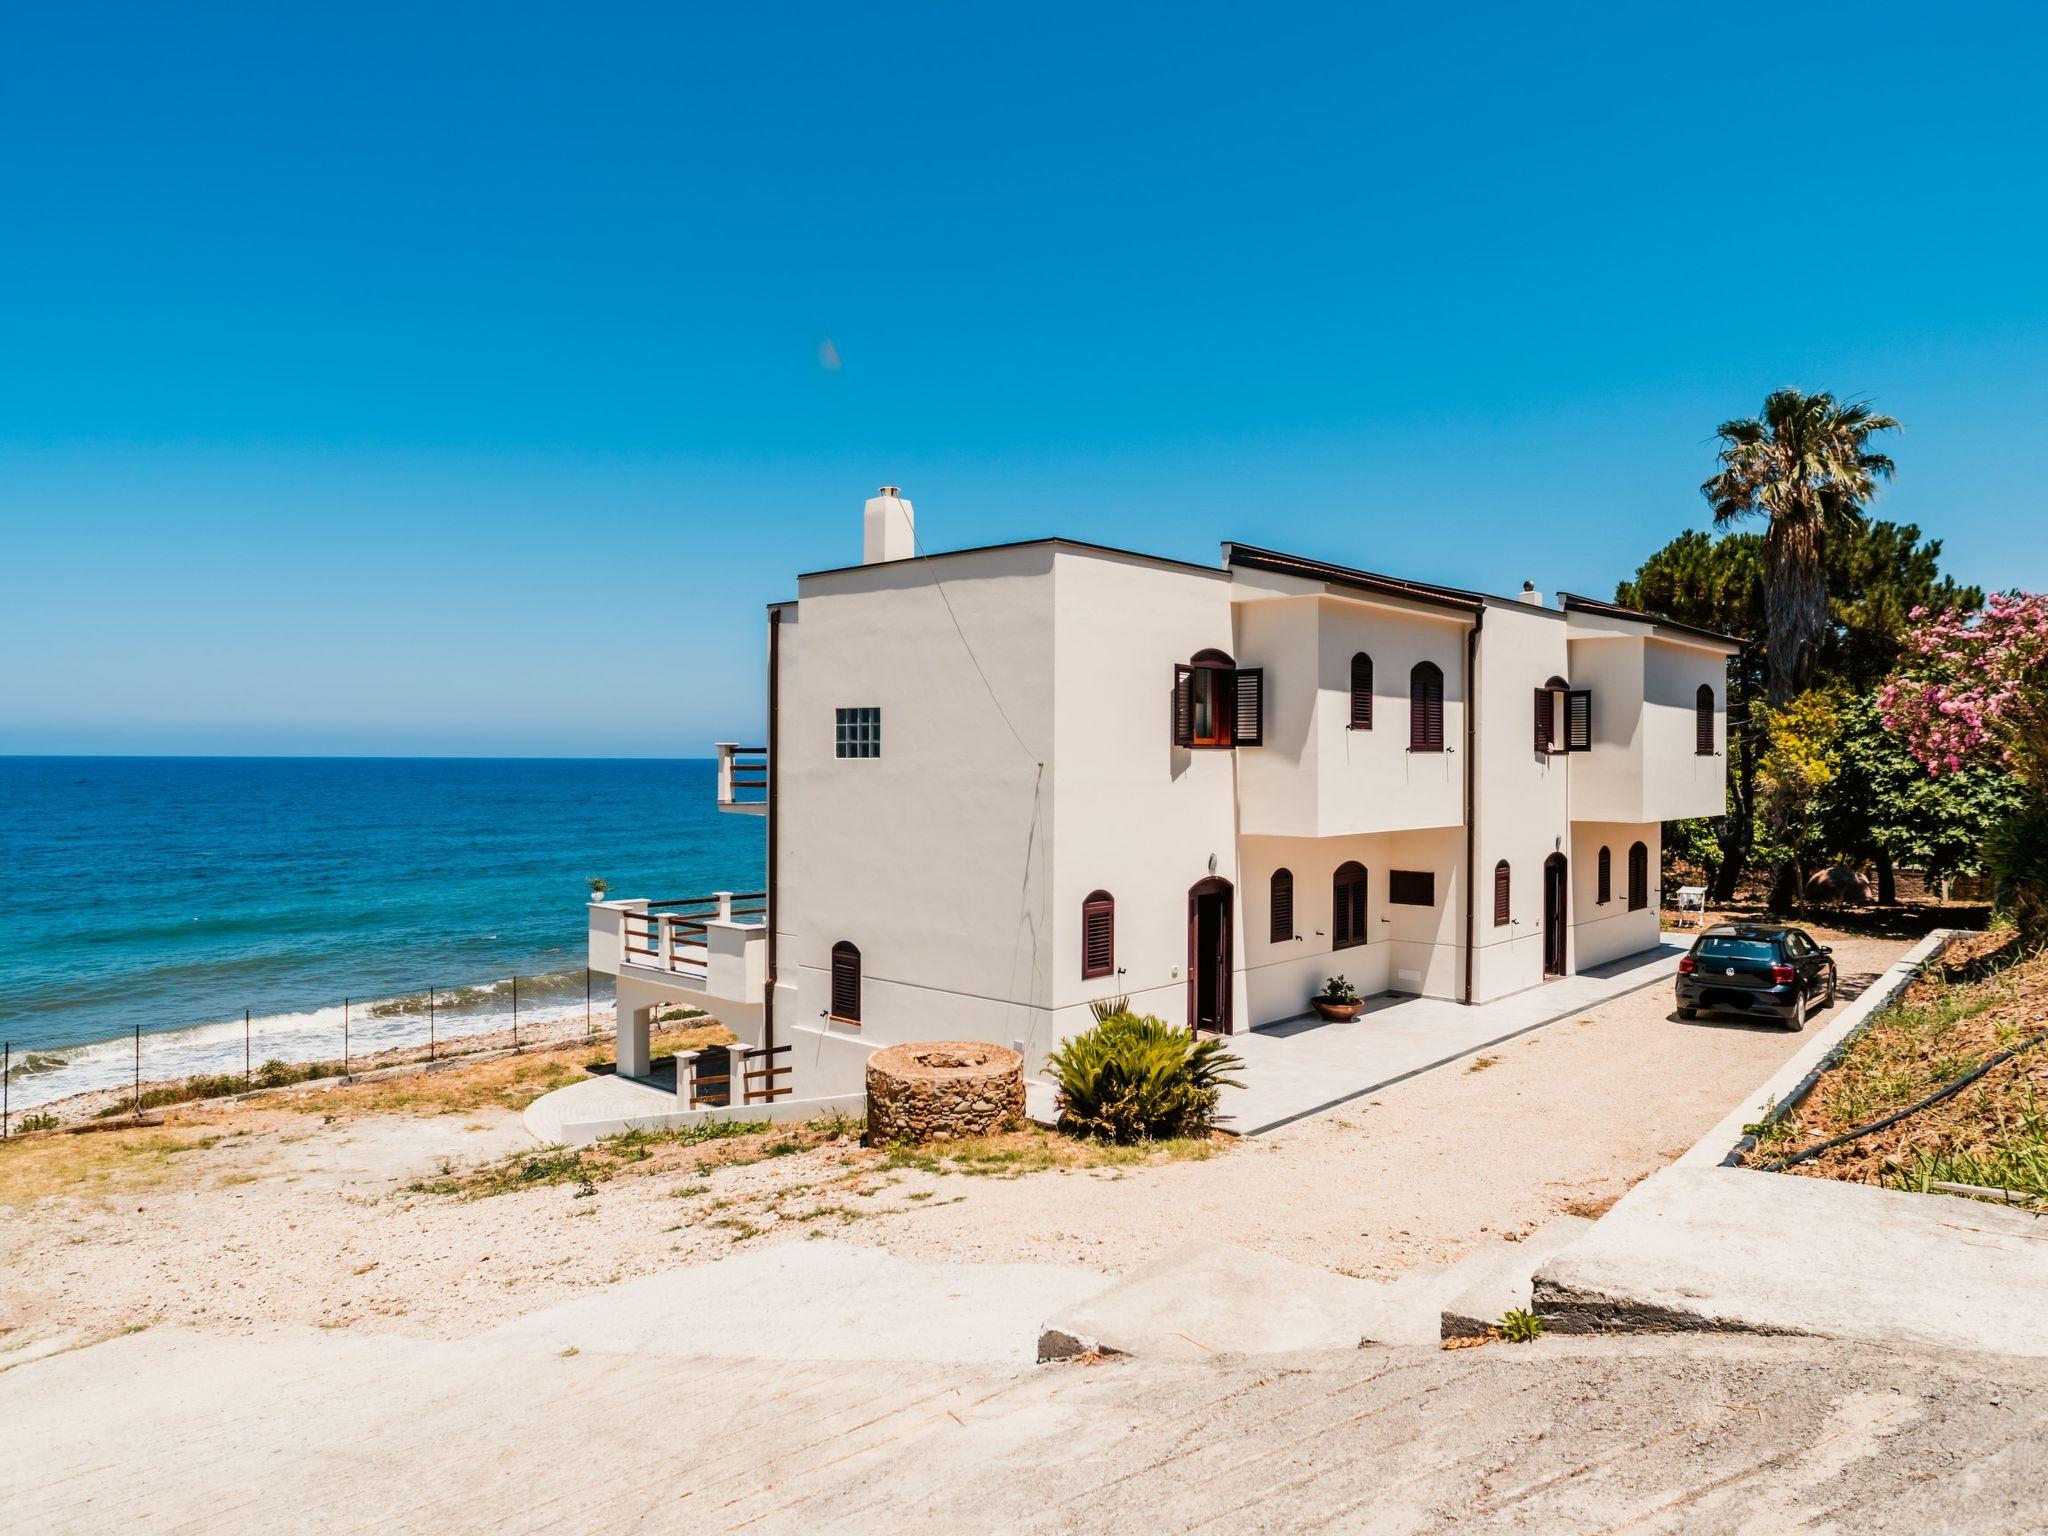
[[0, 969, 614, 1141]]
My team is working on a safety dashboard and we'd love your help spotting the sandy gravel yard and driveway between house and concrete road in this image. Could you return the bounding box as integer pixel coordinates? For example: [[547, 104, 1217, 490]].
[[0, 936, 1905, 1370]]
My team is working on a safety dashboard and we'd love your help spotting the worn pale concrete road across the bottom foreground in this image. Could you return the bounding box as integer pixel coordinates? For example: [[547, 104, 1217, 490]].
[[0, 1315, 2048, 1536]]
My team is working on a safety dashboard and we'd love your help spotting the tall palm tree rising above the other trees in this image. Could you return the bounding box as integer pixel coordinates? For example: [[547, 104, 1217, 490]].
[[1700, 389, 1898, 709]]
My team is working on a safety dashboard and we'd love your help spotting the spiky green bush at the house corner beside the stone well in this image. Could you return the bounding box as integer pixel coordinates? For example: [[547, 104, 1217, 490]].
[[1047, 1012, 1245, 1143]]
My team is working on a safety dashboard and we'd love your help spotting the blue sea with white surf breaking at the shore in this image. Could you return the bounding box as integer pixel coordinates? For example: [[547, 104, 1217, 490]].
[[0, 758, 766, 1110]]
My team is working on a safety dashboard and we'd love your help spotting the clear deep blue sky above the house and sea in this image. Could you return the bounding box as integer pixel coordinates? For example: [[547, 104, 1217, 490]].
[[0, 4, 2048, 756]]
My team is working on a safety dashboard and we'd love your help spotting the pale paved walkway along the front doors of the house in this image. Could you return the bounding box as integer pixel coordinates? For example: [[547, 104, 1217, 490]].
[[1223, 934, 1692, 1137]]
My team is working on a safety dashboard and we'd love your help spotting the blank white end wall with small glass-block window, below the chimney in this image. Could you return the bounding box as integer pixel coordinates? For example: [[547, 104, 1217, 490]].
[[776, 545, 1055, 1092]]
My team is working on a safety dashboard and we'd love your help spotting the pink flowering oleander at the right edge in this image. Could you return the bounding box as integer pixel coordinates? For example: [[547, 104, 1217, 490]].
[[1878, 592, 2048, 774]]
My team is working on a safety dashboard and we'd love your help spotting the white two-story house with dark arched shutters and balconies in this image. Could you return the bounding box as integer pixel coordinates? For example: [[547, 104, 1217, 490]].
[[592, 487, 1739, 1098]]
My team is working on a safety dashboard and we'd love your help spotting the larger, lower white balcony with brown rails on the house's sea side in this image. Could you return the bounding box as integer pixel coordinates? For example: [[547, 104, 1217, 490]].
[[590, 891, 768, 1004]]
